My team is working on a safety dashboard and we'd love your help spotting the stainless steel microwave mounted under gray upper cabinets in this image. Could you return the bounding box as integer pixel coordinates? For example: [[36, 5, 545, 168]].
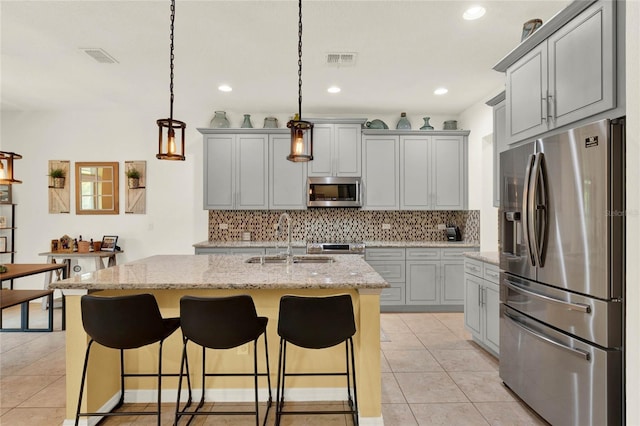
[[307, 177, 362, 207]]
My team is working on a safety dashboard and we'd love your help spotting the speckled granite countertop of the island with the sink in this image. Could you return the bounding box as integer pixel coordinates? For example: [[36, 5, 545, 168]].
[[49, 255, 389, 290]]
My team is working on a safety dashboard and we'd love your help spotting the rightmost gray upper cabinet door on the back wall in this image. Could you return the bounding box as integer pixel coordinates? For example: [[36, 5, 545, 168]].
[[430, 136, 467, 210]]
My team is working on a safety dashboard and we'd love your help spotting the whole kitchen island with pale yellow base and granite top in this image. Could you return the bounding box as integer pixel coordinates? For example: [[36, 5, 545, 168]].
[[50, 255, 389, 425]]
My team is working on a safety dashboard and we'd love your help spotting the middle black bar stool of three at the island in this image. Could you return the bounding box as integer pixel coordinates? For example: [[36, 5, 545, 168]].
[[175, 295, 272, 425]]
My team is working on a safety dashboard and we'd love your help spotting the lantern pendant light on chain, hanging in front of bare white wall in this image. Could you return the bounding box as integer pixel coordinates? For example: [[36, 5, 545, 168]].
[[156, 0, 187, 161]]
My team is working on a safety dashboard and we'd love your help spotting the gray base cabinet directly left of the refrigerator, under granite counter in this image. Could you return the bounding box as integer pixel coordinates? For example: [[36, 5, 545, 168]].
[[464, 258, 500, 356]]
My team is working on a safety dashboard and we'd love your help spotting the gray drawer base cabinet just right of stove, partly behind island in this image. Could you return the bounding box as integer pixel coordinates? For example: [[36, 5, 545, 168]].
[[365, 248, 406, 306]]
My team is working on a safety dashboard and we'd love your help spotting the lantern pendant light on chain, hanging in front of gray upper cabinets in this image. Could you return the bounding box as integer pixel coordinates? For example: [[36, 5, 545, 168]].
[[287, 0, 313, 162]]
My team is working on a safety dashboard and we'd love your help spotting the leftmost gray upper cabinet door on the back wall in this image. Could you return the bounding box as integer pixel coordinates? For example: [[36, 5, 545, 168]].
[[204, 135, 236, 210]]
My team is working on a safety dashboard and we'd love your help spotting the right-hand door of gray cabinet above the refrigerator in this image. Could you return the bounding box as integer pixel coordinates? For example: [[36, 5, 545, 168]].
[[548, 1, 616, 126]]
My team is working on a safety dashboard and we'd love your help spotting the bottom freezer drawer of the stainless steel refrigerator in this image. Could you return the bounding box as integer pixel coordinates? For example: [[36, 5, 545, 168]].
[[500, 304, 623, 425]]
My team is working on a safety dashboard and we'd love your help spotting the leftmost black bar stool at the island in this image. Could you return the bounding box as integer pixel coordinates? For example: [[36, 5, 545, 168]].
[[75, 294, 191, 426]]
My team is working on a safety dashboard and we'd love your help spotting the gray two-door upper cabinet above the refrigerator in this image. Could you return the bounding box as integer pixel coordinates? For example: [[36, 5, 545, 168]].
[[504, 0, 616, 143]]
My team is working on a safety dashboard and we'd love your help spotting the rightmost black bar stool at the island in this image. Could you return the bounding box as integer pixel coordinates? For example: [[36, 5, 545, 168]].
[[276, 294, 358, 425]]
